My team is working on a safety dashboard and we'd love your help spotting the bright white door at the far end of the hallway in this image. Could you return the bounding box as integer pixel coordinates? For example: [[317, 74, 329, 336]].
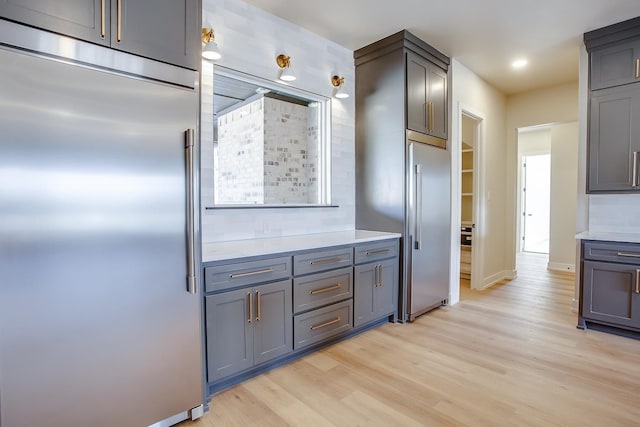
[[522, 154, 551, 254]]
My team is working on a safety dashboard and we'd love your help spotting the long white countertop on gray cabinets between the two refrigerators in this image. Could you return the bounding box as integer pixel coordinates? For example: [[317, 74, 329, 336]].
[[202, 230, 401, 262]]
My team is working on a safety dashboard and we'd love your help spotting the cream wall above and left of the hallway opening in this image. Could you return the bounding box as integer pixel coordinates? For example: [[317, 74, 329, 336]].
[[503, 82, 578, 269]]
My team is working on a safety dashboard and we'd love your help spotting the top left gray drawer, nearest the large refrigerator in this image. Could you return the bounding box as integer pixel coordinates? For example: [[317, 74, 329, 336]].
[[204, 257, 291, 292]]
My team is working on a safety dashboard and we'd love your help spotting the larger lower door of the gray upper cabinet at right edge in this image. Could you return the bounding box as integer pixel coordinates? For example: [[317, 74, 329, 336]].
[[587, 85, 640, 192]]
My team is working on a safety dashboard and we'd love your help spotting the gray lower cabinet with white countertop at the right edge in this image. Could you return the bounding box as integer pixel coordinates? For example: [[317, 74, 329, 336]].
[[579, 241, 640, 331]]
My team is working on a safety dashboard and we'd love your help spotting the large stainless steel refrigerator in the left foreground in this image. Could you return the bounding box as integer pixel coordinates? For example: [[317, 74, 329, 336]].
[[0, 21, 203, 427]]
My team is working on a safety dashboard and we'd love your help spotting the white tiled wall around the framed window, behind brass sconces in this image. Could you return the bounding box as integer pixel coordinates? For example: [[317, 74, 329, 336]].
[[201, 0, 355, 243]]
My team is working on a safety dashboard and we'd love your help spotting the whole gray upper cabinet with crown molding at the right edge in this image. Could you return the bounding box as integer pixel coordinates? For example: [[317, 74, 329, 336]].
[[584, 18, 640, 193]]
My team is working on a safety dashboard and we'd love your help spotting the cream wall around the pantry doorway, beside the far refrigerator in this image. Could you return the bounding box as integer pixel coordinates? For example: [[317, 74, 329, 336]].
[[449, 58, 510, 304]]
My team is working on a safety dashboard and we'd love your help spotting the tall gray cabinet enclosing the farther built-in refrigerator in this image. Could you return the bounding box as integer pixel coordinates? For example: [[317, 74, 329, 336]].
[[354, 30, 451, 321]]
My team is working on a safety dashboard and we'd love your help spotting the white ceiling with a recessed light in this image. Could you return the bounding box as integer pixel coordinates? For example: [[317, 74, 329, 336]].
[[245, 0, 640, 95]]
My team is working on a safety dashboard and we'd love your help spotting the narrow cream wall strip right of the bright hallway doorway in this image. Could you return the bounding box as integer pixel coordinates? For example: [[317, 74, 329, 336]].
[[548, 122, 578, 271]]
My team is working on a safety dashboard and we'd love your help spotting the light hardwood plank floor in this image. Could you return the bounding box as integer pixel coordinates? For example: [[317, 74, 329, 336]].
[[180, 256, 640, 427]]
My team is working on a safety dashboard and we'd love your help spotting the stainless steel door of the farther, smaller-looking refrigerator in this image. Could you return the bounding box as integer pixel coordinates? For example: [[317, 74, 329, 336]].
[[406, 142, 451, 321]]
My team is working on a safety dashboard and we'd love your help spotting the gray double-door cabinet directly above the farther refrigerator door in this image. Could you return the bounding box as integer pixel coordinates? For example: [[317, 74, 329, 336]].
[[407, 52, 447, 139]]
